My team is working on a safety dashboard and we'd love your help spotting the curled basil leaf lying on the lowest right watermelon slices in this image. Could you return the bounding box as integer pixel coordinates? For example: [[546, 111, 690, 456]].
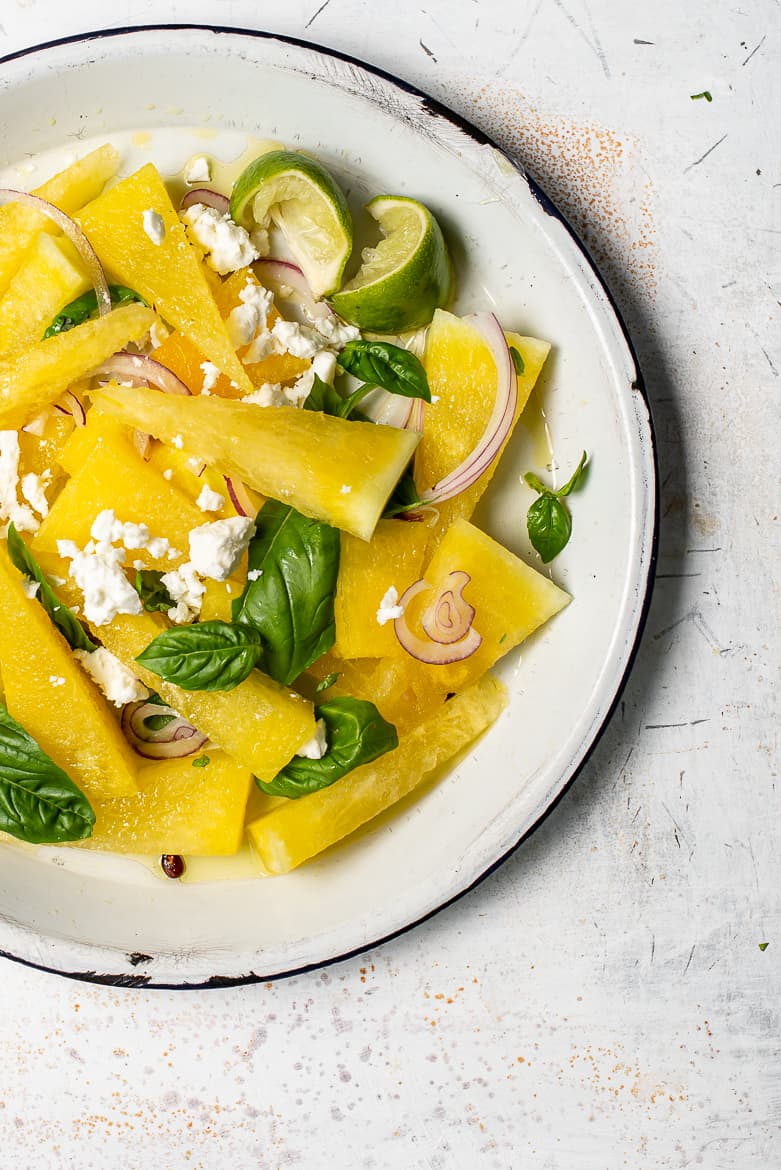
[[255, 696, 399, 800]]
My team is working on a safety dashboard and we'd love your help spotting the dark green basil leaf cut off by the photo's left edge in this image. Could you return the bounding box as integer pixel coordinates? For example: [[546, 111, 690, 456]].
[[0, 703, 95, 845]]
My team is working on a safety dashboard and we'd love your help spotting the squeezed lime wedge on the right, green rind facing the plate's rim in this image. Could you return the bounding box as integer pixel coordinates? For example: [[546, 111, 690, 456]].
[[331, 195, 452, 333]]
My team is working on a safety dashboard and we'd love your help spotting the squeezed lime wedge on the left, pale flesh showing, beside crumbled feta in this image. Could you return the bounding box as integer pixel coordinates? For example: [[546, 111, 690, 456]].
[[230, 150, 353, 297]]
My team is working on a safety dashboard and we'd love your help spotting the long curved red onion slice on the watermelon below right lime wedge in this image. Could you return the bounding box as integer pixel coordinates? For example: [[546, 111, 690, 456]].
[[421, 312, 518, 503]]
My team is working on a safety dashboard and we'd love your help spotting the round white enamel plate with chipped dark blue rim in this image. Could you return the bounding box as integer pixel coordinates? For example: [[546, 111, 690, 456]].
[[0, 28, 656, 986]]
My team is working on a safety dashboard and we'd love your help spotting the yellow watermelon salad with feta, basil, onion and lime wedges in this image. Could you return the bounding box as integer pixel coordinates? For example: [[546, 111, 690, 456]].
[[0, 145, 586, 878]]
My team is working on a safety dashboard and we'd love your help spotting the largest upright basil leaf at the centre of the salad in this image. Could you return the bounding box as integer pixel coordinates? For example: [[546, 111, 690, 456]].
[[233, 500, 339, 687]]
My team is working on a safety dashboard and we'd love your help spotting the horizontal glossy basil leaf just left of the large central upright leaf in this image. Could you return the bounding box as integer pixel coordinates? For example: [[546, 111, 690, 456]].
[[136, 621, 263, 690]]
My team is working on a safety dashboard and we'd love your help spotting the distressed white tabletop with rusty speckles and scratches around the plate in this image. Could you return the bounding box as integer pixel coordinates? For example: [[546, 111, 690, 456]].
[[0, 0, 781, 1170]]
